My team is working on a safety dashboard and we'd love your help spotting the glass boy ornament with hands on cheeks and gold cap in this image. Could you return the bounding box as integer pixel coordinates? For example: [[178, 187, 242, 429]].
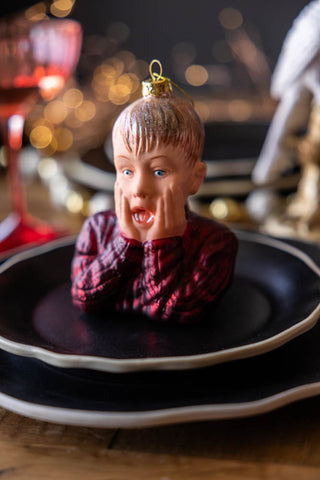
[[72, 60, 237, 323]]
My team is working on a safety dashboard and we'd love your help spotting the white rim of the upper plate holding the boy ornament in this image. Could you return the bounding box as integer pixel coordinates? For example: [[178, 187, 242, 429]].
[[0, 231, 320, 373]]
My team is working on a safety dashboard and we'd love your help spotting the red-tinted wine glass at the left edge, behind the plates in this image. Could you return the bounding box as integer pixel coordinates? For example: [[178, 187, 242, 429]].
[[0, 15, 82, 255]]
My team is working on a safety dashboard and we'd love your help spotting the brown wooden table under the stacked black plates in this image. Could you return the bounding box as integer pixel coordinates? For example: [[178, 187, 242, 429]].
[[0, 173, 320, 480]]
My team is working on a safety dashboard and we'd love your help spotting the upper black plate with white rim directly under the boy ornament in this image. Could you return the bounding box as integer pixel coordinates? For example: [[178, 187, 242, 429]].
[[0, 232, 320, 372]]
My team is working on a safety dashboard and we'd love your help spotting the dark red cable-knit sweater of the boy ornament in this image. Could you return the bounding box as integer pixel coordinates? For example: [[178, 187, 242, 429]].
[[72, 211, 237, 323]]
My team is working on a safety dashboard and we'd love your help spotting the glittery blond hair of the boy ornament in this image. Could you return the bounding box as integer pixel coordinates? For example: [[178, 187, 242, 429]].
[[113, 96, 204, 162]]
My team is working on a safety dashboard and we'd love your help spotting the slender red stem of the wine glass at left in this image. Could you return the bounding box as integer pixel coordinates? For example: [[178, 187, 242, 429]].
[[6, 115, 27, 220]]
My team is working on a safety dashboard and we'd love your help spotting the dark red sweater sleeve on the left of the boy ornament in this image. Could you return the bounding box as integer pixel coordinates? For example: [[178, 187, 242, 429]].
[[71, 213, 143, 312]]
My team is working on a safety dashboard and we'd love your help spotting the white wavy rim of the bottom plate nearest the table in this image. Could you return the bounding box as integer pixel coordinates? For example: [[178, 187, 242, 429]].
[[0, 381, 320, 428]]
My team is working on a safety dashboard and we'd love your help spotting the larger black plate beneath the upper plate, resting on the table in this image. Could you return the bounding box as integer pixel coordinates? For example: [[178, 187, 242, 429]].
[[0, 312, 320, 428]]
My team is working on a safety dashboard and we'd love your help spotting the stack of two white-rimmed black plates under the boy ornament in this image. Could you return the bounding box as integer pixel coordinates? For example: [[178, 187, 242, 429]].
[[0, 232, 320, 427]]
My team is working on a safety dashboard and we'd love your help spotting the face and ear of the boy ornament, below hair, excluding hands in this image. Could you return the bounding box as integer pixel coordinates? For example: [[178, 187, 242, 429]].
[[113, 131, 206, 228]]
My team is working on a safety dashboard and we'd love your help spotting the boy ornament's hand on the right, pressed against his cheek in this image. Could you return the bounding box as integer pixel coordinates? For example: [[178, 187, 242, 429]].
[[146, 186, 187, 240]]
